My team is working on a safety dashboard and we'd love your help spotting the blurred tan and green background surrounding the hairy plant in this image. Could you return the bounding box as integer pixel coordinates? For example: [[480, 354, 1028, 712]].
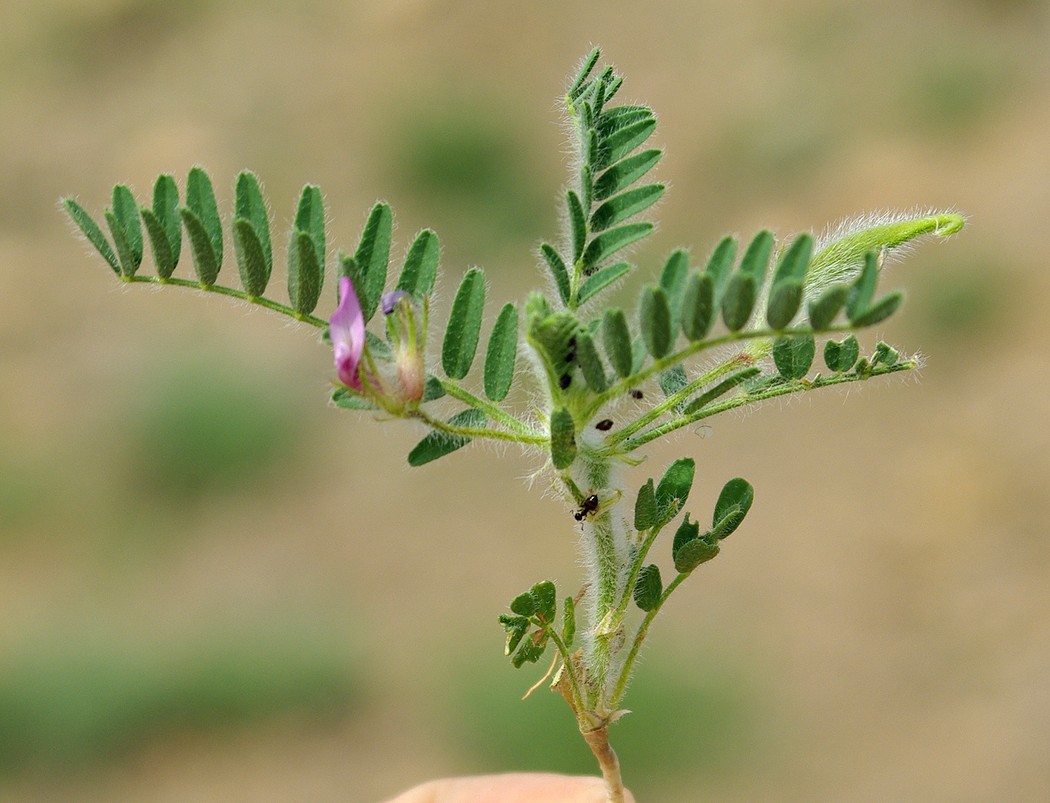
[[0, 0, 1050, 801]]
